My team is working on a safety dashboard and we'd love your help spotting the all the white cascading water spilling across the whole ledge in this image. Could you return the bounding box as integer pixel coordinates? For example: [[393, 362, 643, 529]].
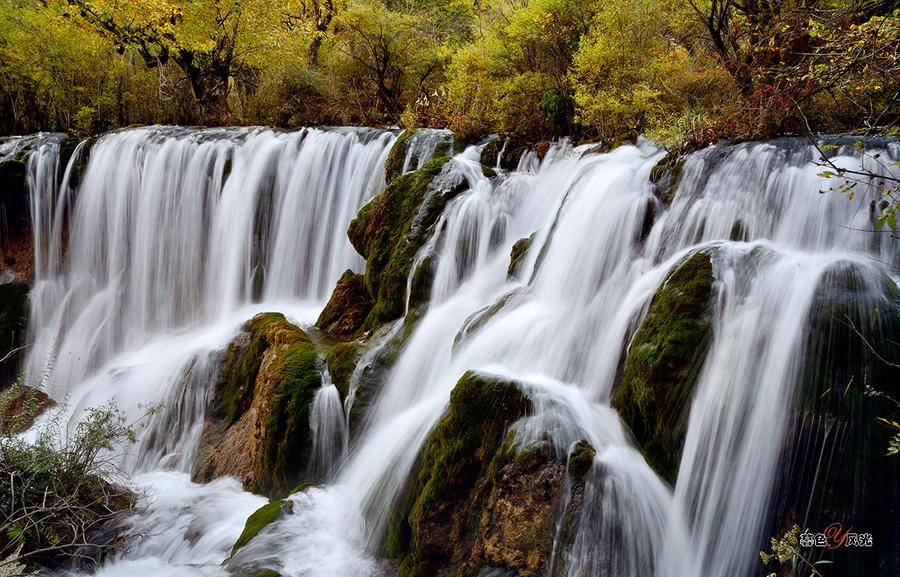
[[10, 129, 900, 577]]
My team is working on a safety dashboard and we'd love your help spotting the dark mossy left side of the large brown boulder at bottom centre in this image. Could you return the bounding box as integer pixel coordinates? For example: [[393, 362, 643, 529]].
[[389, 371, 531, 576]]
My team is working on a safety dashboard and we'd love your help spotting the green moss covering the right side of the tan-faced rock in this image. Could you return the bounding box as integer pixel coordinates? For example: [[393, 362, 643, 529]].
[[256, 331, 322, 495]]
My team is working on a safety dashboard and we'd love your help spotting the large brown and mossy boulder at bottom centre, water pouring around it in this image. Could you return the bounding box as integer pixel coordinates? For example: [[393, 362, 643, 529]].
[[385, 372, 593, 577]]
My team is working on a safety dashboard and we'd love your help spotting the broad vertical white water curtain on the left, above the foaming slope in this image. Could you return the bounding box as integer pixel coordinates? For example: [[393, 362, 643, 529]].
[[26, 127, 394, 396]]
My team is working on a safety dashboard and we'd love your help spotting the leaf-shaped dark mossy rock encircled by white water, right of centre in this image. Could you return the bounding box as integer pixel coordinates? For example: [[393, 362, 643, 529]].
[[612, 251, 714, 483]]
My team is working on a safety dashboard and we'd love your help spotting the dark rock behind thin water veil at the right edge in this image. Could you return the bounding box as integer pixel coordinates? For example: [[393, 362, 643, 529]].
[[766, 262, 900, 575]]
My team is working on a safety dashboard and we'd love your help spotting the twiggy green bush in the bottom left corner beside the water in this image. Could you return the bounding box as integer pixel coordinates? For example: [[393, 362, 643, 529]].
[[0, 406, 135, 573]]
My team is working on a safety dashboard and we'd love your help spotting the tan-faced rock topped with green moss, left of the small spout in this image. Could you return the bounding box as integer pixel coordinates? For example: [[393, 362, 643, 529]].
[[192, 313, 322, 496]]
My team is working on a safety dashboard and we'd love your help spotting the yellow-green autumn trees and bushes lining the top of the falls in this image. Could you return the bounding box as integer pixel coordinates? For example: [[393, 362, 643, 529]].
[[0, 0, 900, 146]]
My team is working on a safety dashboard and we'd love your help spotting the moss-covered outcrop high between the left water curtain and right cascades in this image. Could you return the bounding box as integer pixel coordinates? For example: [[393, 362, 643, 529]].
[[347, 157, 461, 330]]
